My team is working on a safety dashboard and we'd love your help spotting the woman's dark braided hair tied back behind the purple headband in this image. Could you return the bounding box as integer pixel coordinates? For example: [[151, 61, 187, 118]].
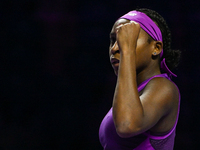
[[136, 8, 181, 70]]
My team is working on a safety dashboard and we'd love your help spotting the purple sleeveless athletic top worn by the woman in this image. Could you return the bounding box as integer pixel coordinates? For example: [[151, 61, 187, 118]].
[[99, 73, 180, 150]]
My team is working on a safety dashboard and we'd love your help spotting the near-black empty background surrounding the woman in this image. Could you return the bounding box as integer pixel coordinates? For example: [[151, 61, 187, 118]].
[[0, 0, 200, 150]]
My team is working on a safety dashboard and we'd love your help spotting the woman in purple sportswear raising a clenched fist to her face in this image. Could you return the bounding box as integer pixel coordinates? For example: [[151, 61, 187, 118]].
[[99, 9, 180, 150]]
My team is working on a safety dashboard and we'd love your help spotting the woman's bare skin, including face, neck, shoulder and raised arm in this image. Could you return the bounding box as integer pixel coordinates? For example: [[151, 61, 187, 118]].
[[109, 19, 179, 138]]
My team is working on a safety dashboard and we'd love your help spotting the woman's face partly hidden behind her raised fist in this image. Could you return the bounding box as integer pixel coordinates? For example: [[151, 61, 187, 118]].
[[109, 19, 154, 75]]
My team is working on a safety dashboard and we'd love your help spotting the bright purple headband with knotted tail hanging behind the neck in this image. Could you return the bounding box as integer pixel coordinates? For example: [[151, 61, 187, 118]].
[[119, 10, 177, 78]]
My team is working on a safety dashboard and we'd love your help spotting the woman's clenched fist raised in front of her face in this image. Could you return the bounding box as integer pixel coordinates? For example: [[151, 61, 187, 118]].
[[116, 21, 140, 52]]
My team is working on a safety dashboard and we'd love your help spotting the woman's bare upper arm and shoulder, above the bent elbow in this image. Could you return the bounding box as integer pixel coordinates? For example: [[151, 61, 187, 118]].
[[140, 78, 178, 132]]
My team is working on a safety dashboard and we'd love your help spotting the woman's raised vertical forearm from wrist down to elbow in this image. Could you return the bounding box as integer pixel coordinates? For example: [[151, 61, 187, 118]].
[[113, 49, 144, 136]]
